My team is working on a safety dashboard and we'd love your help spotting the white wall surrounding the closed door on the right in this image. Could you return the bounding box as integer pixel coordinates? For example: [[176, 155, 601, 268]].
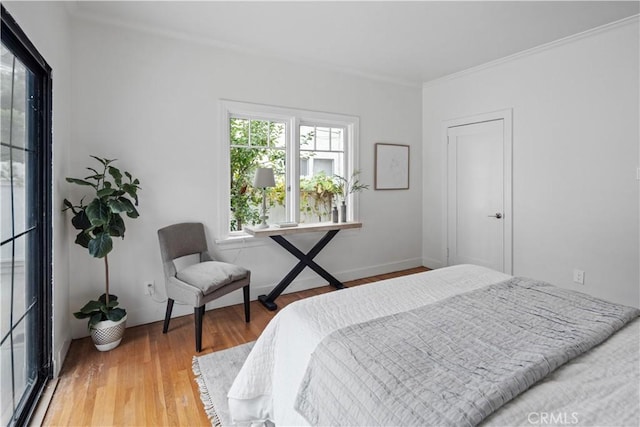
[[423, 17, 640, 306]]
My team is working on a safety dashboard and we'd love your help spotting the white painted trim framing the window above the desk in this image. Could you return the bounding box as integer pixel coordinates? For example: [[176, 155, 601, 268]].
[[216, 99, 360, 243]]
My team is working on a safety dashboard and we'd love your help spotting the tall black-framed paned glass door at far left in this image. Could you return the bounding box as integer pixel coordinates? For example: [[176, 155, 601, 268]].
[[0, 7, 52, 425]]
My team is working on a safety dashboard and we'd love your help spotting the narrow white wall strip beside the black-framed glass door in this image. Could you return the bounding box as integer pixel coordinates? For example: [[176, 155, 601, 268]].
[[3, 2, 71, 375]]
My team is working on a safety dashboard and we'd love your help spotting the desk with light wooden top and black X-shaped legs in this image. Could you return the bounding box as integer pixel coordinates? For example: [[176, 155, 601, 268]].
[[244, 222, 362, 311]]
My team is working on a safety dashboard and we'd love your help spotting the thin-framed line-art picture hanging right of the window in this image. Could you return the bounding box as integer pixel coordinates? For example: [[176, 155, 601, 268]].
[[374, 142, 409, 190]]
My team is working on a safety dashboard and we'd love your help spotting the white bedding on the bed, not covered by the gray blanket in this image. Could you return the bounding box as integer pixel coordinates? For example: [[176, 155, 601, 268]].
[[228, 265, 640, 426]]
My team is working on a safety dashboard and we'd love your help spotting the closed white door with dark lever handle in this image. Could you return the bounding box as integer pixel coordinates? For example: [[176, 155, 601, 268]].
[[447, 119, 511, 273]]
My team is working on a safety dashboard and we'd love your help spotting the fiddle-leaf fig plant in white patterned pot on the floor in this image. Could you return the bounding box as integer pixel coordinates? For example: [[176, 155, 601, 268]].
[[63, 156, 140, 351]]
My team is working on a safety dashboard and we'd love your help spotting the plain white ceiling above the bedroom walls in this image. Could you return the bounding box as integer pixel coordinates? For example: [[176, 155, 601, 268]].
[[71, 1, 640, 85]]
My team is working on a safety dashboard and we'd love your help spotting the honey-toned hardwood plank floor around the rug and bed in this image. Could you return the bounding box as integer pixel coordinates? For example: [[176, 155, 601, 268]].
[[43, 267, 427, 426]]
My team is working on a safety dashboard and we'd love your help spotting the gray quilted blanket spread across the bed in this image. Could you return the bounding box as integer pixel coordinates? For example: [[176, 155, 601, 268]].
[[296, 278, 640, 426]]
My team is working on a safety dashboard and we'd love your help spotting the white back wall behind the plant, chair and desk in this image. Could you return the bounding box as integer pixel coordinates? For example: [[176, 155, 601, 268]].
[[67, 20, 422, 337]]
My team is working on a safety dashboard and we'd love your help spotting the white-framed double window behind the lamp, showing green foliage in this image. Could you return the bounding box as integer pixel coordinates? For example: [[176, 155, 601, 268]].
[[219, 101, 358, 238]]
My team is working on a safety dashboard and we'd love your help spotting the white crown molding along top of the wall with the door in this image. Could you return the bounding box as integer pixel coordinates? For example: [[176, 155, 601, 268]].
[[422, 14, 640, 88]]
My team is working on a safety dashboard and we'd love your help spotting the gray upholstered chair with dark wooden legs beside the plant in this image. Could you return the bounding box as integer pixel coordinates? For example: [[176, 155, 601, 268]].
[[158, 223, 251, 352]]
